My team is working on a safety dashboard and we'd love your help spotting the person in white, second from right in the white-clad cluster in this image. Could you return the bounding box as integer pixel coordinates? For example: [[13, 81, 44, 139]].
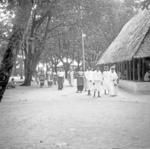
[[103, 66, 109, 95]]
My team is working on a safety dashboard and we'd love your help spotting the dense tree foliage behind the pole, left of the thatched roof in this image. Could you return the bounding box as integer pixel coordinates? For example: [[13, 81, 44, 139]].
[[0, 0, 139, 75]]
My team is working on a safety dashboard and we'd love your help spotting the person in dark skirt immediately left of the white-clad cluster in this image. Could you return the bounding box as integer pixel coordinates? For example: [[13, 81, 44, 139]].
[[77, 71, 84, 93]]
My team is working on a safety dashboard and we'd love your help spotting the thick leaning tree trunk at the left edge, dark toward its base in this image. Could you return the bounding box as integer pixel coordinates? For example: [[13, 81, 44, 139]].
[[0, 0, 32, 102]]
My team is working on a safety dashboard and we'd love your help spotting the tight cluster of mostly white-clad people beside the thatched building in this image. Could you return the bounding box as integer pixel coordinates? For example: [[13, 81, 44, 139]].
[[77, 65, 119, 97]]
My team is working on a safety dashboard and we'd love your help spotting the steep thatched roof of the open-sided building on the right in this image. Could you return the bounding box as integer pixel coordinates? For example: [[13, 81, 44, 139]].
[[98, 10, 150, 64]]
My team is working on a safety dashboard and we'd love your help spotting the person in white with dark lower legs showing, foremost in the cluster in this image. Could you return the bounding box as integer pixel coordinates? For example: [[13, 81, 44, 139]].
[[93, 68, 102, 97]]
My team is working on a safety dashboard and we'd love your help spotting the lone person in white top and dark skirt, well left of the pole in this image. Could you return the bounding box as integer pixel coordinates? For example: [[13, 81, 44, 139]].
[[57, 69, 65, 90]]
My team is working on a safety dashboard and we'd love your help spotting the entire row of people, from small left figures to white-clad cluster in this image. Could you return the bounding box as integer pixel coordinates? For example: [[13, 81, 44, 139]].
[[36, 65, 119, 97]]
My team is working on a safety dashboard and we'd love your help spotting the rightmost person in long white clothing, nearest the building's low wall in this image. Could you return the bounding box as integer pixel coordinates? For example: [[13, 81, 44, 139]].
[[109, 65, 118, 97]]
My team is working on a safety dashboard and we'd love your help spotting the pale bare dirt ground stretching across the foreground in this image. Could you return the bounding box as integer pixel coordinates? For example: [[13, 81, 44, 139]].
[[0, 84, 150, 149]]
